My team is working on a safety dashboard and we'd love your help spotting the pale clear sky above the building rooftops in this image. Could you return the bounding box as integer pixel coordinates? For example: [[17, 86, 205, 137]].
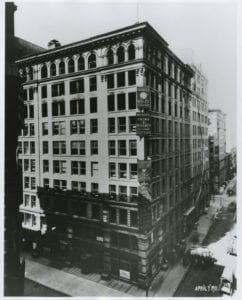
[[15, 0, 237, 151]]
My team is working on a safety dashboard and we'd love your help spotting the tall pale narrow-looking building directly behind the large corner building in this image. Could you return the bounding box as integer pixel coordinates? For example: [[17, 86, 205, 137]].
[[191, 64, 209, 217]]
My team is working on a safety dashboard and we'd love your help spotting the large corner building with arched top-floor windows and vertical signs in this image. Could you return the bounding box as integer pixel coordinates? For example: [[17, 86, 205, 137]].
[[17, 22, 194, 287]]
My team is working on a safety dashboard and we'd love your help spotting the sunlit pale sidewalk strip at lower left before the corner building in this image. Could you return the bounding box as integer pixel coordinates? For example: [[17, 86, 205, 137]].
[[25, 259, 128, 297]]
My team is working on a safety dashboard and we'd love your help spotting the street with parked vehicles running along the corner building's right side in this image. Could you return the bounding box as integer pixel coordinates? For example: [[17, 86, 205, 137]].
[[174, 183, 236, 297]]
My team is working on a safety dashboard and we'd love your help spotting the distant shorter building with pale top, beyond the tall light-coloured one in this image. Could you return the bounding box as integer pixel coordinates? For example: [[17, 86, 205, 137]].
[[208, 109, 228, 193]]
